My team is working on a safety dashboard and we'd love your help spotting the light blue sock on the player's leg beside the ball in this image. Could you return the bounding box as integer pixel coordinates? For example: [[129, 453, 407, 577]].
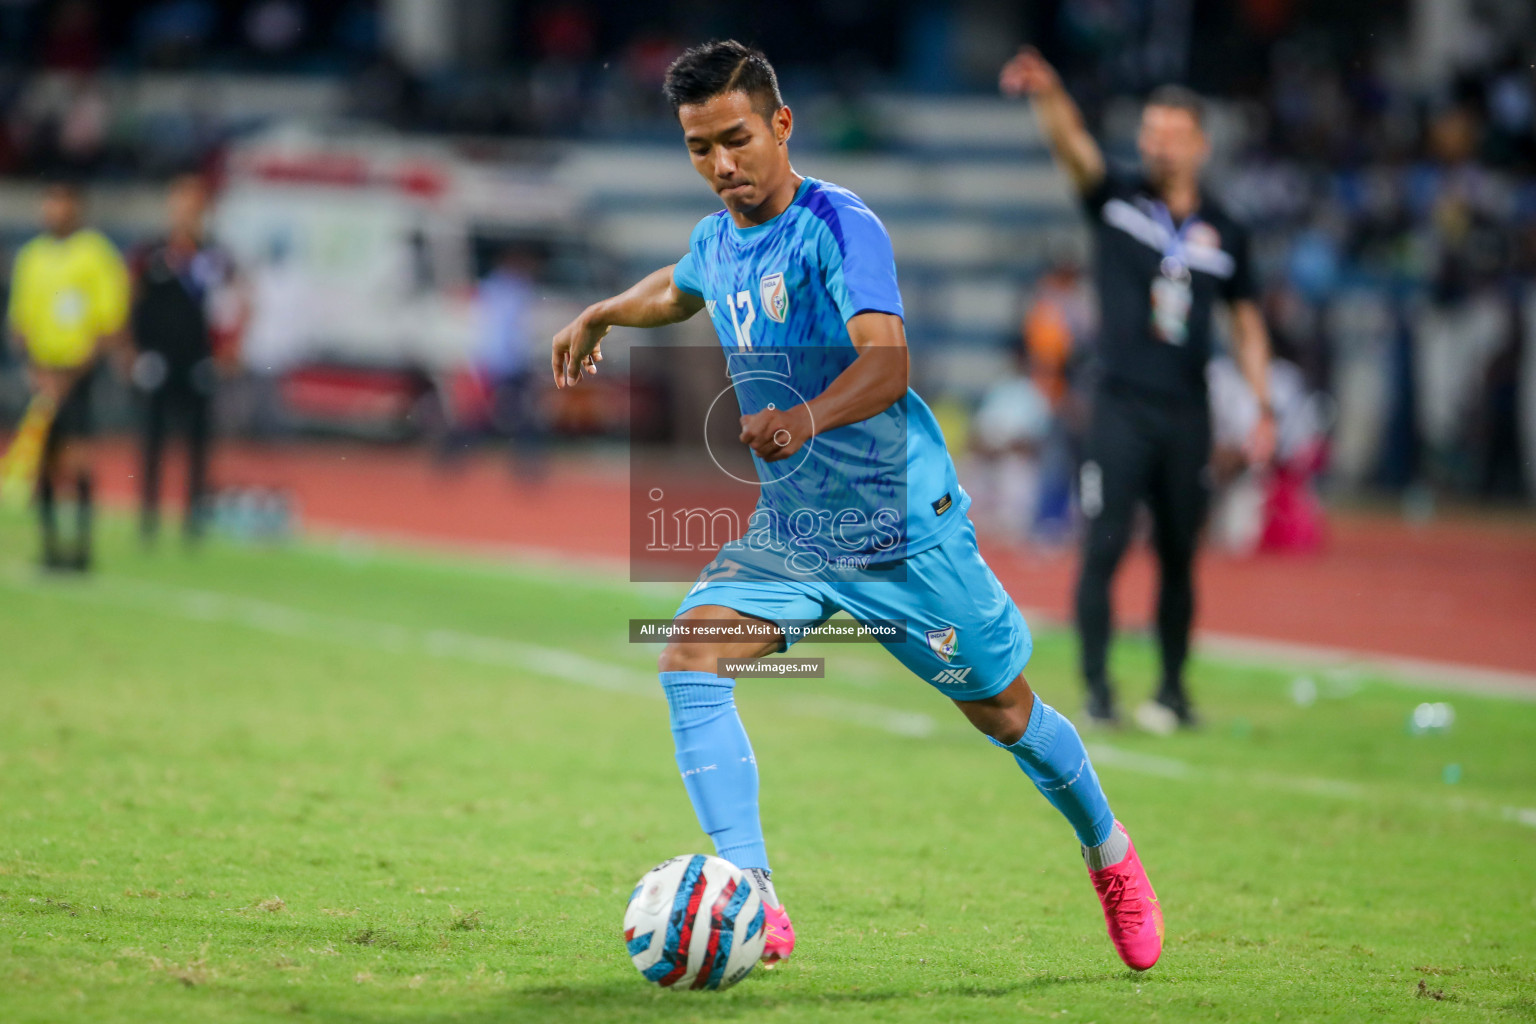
[[660, 672, 768, 870]]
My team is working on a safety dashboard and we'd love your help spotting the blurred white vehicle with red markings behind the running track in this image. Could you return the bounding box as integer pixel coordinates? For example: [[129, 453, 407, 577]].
[[214, 126, 591, 436]]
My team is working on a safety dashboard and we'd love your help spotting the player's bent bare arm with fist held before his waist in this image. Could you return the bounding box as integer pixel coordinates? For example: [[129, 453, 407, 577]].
[[742, 313, 909, 462]]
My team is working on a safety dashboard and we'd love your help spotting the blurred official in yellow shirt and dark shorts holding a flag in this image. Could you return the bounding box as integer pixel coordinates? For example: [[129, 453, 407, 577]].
[[8, 181, 129, 571]]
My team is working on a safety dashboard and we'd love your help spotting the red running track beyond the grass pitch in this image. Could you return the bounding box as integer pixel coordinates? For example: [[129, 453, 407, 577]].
[[77, 442, 1536, 674]]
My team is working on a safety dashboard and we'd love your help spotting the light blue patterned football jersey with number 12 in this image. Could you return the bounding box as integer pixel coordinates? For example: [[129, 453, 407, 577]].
[[673, 178, 971, 560]]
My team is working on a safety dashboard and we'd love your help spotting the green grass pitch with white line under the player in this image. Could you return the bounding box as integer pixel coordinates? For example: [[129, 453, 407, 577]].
[[0, 517, 1536, 1024]]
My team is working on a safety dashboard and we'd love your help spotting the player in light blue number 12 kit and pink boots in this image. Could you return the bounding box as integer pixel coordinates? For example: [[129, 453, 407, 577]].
[[551, 41, 1163, 970]]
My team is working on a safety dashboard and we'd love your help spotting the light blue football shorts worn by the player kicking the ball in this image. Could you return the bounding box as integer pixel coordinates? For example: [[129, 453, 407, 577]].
[[676, 519, 1034, 700]]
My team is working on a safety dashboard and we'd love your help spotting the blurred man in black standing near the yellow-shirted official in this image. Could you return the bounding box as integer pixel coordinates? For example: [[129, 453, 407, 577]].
[[131, 175, 233, 542]]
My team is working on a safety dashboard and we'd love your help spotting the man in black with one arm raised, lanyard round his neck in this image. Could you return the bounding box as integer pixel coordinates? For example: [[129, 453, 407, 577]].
[[1000, 49, 1275, 732]]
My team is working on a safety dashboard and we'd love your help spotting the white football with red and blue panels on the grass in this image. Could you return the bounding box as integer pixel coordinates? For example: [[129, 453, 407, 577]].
[[624, 854, 766, 989]]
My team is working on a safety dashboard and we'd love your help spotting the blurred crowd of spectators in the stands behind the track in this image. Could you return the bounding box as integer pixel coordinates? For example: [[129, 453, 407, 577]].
[[0, 0, 1536, 533]]
